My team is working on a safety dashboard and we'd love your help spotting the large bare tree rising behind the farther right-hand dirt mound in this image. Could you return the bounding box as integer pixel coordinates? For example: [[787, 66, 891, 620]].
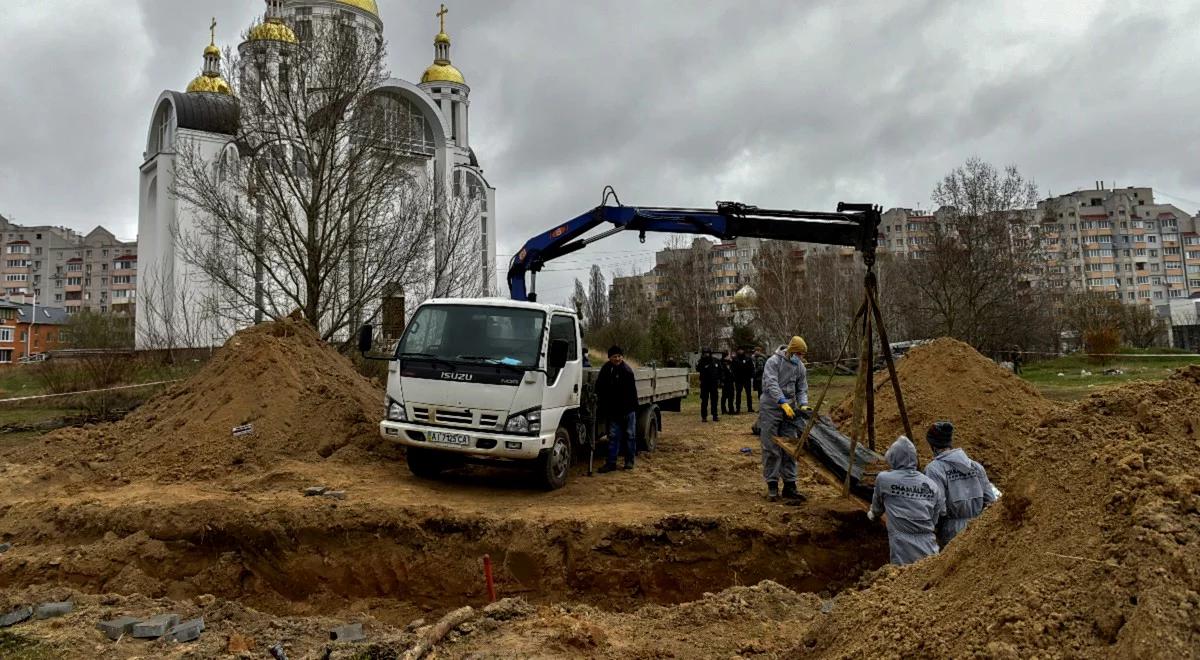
[[908, 158, 1045, 349]]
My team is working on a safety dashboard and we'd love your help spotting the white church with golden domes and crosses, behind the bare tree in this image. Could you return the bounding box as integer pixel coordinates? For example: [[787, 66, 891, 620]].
[[136, 0, 497, 348]]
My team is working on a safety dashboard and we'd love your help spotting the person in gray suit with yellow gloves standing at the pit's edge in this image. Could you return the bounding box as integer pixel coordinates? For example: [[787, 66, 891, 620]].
[[758, 337, 812, 503]]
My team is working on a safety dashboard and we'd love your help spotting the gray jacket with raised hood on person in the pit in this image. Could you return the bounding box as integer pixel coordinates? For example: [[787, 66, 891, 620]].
[[871, 436, 946, 537]]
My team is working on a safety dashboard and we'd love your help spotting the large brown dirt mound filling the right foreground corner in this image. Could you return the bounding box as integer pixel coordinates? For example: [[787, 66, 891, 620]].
[[805, 366, 1200, 658]]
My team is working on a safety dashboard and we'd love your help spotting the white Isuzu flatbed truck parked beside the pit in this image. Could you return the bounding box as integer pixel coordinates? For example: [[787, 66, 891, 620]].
[[359, 299, 688, 490]]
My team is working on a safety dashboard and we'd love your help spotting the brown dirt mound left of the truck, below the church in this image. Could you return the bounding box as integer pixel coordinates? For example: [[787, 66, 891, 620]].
[[18, 319, 383, 481]]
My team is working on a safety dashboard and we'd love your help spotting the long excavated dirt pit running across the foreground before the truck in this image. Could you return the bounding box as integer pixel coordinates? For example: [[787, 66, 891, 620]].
[[0, 511, 887, 623]]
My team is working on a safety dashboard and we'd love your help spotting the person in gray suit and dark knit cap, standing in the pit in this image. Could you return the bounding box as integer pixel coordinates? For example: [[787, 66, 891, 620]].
[[925, 421, 998, 550]]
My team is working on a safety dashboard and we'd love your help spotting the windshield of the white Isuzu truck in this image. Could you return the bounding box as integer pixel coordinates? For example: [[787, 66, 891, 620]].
[[396, 305, 546, 367]]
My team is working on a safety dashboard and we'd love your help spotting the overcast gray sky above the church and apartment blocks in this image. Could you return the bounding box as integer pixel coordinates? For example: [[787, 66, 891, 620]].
[[0, 0, 1200, 300]]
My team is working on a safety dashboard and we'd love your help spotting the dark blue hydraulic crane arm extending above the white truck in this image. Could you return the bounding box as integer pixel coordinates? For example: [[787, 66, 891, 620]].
[[509, 192, 880, 301]]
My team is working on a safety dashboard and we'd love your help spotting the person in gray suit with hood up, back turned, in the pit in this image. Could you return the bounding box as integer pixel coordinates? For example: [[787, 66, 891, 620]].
[[866, 436, 946, 565]]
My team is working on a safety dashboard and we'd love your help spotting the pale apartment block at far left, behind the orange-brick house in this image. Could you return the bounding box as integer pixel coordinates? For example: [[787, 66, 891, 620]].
[[0, 216, 137, 313]]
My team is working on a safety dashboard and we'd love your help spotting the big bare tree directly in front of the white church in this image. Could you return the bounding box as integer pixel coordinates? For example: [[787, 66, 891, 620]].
[[173, 22, 448, 338]]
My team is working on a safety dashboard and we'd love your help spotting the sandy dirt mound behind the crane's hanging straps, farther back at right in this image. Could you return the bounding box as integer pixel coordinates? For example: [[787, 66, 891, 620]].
[[832, 338, 1055, 484]]
